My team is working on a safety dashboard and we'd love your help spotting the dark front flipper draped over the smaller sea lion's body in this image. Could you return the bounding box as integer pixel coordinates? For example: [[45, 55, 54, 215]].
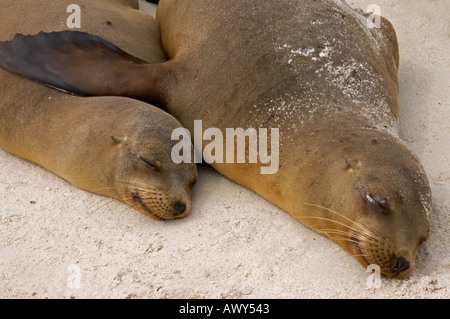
[[0, 31, 170, 106]]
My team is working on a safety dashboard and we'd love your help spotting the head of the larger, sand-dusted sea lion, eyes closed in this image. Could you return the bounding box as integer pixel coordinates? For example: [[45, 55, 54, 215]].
[[302, 131, 431, 278]]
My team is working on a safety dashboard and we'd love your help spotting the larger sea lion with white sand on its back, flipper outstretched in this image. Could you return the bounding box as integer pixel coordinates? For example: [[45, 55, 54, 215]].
[[0, 0, 431, 278]]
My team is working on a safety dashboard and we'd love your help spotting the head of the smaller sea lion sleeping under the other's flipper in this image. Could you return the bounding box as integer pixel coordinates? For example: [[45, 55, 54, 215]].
[[111, 110, 197, 219]]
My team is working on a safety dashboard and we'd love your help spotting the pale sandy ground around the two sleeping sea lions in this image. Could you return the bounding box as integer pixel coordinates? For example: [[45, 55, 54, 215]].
[[0, 0, 450, 298]]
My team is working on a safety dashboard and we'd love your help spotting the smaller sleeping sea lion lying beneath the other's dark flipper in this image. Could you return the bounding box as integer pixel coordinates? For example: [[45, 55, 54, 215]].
[[0, 0, 197, 219]]
